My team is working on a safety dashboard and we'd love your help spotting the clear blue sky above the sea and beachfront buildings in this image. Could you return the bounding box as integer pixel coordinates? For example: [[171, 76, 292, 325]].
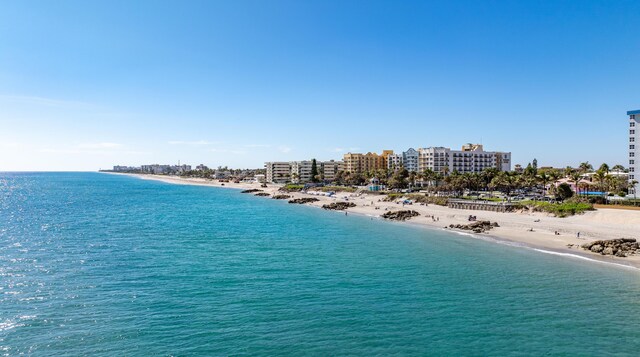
[[0, 0, 640, 171]]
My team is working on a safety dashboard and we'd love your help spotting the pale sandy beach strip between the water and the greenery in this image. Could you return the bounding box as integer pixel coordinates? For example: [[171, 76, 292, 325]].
[[112, 173, 640, 270]]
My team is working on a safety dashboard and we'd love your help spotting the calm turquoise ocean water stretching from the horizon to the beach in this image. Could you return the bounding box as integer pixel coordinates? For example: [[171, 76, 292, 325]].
[[0, 173, 640, 356]]
